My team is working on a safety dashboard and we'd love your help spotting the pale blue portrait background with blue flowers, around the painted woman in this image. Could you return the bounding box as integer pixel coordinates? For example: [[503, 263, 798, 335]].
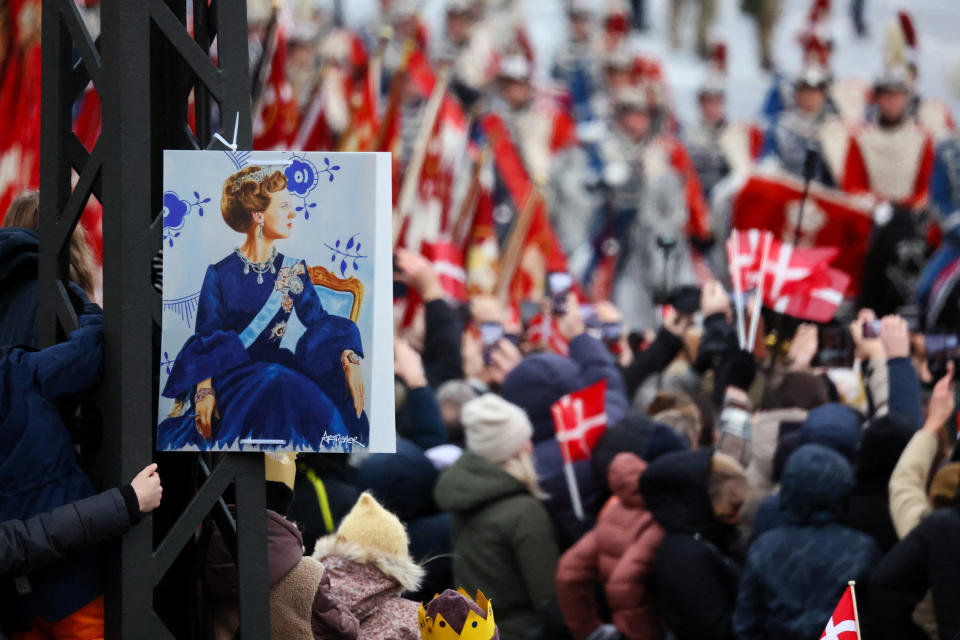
[[158, 151, 395, 452]]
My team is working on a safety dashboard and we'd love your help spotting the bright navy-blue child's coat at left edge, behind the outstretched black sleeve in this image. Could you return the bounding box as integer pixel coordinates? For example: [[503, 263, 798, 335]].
[[0, 296, 103, 628]]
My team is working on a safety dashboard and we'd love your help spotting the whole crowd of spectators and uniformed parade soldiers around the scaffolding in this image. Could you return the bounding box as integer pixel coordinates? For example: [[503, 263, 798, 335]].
[[0, 0, 960, 640]]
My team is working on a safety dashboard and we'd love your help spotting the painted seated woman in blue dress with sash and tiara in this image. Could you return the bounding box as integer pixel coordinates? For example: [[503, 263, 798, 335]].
[[157, 166, 370, 451]]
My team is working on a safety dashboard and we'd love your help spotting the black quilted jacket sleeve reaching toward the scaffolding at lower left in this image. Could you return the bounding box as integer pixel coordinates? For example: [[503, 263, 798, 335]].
[[0, 489, 131, 576]]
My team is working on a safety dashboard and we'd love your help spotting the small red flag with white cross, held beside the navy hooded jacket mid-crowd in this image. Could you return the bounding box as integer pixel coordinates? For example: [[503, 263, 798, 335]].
[[550, 379, 607, 463]]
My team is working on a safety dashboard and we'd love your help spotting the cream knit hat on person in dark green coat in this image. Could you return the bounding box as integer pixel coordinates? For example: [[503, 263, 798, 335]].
[[460, 393, 533, 464]]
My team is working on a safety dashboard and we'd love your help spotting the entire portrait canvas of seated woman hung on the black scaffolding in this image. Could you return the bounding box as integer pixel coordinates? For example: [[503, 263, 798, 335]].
[[157, 151, 395, 452]]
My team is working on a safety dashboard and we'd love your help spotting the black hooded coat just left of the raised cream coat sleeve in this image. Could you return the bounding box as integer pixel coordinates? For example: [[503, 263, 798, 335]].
[[846, 413, 915, 553]]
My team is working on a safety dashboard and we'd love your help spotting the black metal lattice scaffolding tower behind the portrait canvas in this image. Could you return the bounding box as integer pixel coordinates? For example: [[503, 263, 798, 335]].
[[38, 0, 270, 639]]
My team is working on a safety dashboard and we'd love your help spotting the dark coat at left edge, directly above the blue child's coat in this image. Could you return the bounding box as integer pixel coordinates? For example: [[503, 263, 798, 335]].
[[0, 227, 40, 347]]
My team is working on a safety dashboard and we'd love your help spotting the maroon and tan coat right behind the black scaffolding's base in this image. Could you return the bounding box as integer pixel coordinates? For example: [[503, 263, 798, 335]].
[[205, 510, 359, 640]]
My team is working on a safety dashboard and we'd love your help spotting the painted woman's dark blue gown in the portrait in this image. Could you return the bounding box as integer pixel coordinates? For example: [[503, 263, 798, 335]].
[[157, 253, 370, 451]]
